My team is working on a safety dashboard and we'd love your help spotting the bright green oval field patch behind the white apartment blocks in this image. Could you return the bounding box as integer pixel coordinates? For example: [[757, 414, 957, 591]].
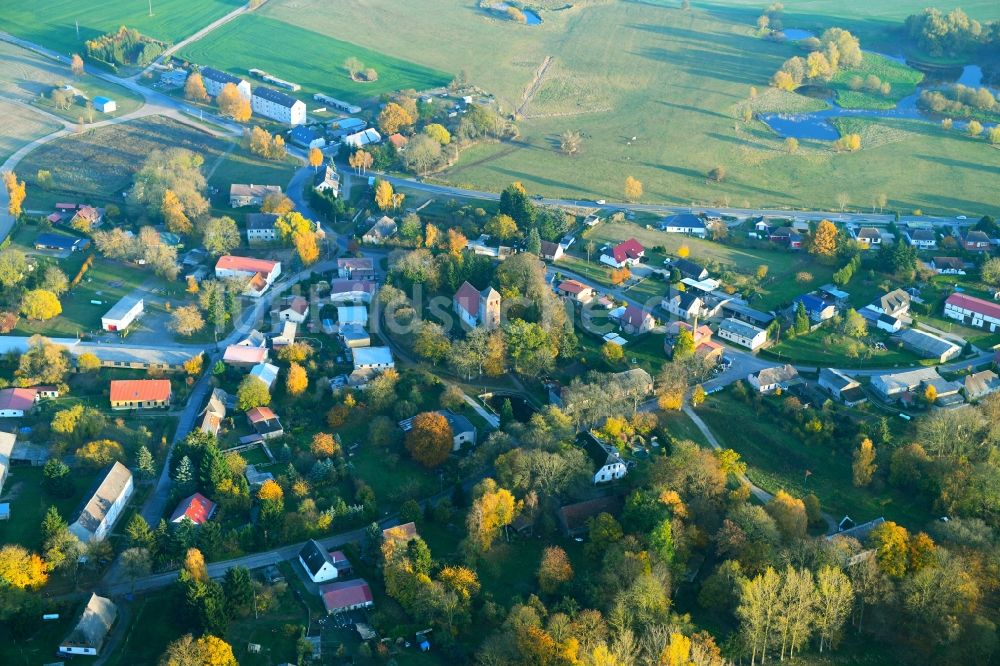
[[180, 13, 454, 106]]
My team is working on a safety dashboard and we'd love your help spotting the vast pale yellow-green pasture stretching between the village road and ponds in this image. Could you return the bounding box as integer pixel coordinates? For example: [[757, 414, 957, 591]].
[[261, 0, 1000, 214]]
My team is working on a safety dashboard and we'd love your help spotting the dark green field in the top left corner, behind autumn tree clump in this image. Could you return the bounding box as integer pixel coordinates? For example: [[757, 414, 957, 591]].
[[0, 0, 243, 54]]
